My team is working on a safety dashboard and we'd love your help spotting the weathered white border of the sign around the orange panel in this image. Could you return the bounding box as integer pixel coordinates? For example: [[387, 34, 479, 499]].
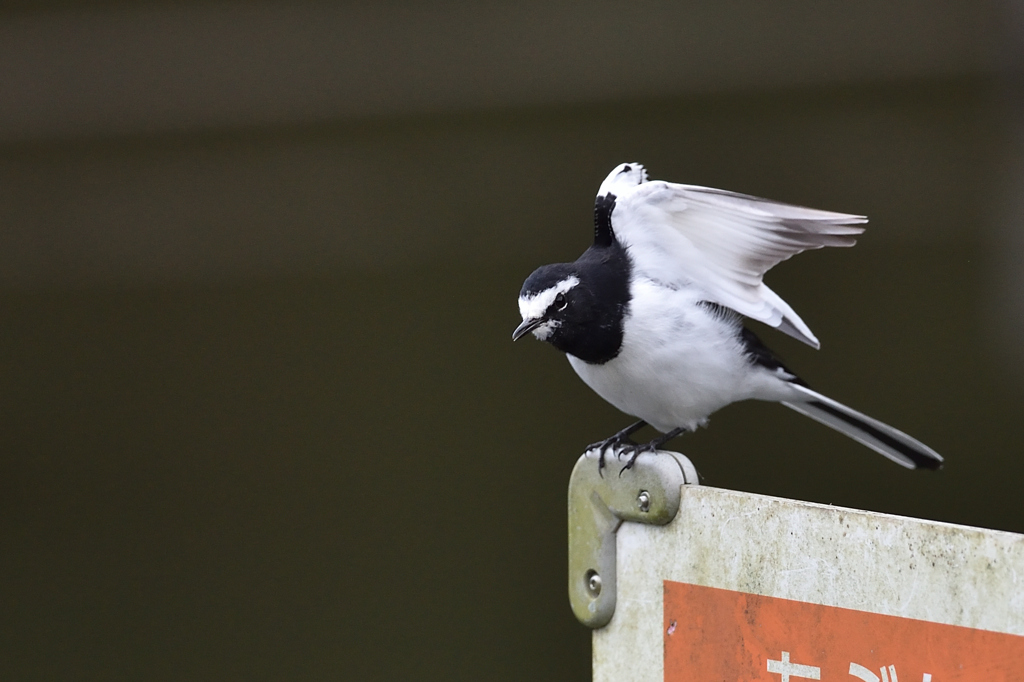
[[593, 486, 1024, 682]]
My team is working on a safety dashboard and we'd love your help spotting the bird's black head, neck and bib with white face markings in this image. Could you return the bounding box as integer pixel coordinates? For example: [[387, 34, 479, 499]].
[[512, 246, 629, 365]]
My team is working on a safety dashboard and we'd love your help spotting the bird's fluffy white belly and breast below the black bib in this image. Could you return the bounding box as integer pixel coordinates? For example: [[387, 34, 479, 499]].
[[568, 281, 790, 432]]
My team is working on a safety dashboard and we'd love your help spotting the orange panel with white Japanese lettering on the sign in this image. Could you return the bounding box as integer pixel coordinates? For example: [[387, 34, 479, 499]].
[[664, 581, 1024, 682]]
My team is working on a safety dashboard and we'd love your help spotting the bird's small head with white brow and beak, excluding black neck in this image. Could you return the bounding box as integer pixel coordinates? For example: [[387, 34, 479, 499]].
[[512, 263, 583, 347]]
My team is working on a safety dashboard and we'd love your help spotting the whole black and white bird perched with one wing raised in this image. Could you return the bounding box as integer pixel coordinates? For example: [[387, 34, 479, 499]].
[[512, 164, 942, 469]]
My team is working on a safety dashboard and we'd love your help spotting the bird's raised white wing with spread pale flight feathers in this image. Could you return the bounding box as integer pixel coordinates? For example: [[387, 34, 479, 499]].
[[602, 164, 867, 348]]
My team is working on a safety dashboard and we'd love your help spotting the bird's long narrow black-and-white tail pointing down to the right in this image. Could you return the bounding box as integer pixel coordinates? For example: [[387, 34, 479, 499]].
[[782, 384, 942, 469]]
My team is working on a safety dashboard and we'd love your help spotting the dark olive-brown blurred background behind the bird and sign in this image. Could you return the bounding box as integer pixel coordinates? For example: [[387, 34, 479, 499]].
[[0, 0, 1024, 680]]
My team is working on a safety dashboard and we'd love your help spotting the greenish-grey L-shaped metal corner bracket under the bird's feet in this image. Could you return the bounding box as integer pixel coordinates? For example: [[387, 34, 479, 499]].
[[569, 451, 697, 629]]
